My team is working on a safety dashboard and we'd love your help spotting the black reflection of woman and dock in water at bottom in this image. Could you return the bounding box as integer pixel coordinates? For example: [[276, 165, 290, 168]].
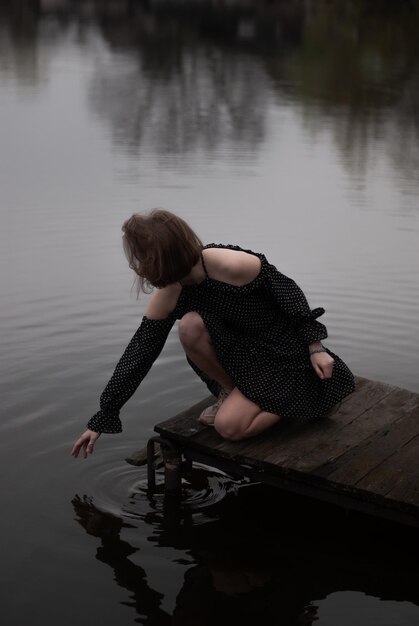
[[73, 476, 419, 626]]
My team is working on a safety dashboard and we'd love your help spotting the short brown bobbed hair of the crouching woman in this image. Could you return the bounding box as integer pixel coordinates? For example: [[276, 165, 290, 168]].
[[122, 209, 203, 291]]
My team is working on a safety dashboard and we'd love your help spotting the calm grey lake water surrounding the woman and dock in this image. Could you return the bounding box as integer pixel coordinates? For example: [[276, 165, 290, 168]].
[[0, 0, 419, 626]]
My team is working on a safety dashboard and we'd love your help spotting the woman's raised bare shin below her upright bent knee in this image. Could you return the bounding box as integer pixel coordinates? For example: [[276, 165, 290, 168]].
[[179, 311, 234, 391]]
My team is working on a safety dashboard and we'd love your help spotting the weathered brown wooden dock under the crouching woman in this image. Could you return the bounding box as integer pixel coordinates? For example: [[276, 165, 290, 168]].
[[127, 378, 419, 526]]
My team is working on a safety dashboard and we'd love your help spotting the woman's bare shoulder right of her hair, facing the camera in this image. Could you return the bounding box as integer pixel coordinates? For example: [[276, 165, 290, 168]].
[[203, 248, 261, 287]]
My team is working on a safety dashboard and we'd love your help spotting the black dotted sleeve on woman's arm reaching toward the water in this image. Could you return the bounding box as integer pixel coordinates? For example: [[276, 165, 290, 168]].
[[87, 316, 175, 433]]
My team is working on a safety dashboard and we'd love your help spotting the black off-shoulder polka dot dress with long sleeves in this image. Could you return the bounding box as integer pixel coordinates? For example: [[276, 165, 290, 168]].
[[87, 244, 355, 433]]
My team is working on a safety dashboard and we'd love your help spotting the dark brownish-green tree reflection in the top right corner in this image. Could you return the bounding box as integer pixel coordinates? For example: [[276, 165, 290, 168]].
[[267, 2, 419, 180]]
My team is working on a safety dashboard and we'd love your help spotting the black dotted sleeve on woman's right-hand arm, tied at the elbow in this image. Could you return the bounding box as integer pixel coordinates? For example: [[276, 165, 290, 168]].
[[262, 259, 327, 344]]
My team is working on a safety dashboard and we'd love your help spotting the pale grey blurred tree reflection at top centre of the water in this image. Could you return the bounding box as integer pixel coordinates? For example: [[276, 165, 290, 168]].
[[90, 18, 267, 156]]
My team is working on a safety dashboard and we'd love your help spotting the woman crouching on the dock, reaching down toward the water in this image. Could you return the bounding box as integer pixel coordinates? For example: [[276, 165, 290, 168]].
[[72, 209, 354, 457]]
